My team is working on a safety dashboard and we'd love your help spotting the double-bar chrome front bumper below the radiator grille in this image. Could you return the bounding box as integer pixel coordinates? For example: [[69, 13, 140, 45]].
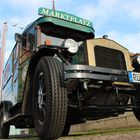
[[64, 65, 129, 83]]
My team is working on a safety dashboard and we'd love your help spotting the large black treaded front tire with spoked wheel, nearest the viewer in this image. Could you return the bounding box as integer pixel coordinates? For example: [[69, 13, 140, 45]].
[[32, 57, 67, 140]]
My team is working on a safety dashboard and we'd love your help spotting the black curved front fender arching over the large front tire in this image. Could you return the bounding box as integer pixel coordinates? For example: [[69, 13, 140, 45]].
[[21, 46, 57, 115]]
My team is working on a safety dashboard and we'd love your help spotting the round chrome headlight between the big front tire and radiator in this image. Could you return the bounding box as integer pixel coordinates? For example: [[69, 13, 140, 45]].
[[64, 39, 78, 54]]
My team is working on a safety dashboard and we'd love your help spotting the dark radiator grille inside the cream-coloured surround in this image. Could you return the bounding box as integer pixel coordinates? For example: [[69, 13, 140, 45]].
[[94, 46, 126, 70]]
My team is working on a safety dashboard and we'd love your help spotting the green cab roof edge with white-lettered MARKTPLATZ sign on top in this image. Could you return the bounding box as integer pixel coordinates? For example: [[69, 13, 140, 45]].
[[23, 8, 95, 35]]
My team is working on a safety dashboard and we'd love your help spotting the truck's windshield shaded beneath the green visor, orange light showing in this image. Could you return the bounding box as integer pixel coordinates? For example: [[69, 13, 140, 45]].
[[40, 22, 93, 46]]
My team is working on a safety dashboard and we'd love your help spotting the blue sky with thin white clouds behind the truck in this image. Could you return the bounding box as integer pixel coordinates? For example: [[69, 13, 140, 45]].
[[0, 0, 140, 59]]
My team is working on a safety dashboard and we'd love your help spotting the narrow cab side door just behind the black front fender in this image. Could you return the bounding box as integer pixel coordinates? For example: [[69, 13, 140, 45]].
[[15, 29, 35, 102]]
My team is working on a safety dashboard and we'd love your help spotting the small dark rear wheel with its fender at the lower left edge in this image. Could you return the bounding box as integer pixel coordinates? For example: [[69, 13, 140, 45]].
[[0, 101, 11, 139]]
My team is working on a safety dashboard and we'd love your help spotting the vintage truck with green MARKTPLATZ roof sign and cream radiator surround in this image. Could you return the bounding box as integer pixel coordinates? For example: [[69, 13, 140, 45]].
[[0, 8, 140, 140]]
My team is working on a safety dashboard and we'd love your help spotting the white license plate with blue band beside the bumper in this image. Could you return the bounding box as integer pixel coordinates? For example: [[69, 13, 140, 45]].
[[128, 72, 140, 83]]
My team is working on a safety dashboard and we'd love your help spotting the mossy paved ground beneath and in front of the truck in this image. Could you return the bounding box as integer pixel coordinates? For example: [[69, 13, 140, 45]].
[[5, 127, 140, 140]]
